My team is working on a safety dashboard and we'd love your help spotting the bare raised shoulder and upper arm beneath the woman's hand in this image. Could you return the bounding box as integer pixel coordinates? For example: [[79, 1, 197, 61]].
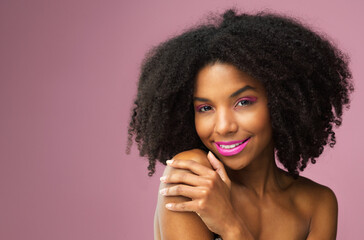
[[155, 149, 213, 240]]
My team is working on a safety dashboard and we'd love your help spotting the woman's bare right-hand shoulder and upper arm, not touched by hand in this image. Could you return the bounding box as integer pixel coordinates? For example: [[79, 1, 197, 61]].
[[292, 177, 338, 240]]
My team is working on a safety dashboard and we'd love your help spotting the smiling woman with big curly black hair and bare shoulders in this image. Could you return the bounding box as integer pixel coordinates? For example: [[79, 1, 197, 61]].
[[128, 10, 353, 240]]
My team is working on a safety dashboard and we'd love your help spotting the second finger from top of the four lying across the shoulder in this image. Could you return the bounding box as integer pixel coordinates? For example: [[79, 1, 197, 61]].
[[160, 169, 212, 186]]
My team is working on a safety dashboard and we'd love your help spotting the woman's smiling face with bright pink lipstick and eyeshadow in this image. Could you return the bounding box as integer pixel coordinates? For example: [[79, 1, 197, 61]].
[[194, 63, 273, 170]]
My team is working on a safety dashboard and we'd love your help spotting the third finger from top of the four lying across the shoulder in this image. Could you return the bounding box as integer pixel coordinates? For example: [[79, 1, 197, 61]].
[[159, 185, 206, 199]]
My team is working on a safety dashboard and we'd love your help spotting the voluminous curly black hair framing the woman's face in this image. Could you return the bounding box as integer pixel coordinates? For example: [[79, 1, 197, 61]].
[[127, 9, 354, 177]]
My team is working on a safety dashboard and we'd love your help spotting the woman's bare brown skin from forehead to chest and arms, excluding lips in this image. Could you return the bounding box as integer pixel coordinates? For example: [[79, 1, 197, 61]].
[[154, 63, 338, 240]]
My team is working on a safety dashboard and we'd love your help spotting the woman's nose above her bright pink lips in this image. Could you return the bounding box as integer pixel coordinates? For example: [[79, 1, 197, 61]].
[[215, 109, 238, 136]]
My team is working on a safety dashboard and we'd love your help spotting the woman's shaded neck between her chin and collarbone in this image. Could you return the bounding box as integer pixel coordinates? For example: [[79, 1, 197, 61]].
[[227, 144, 283, 197]]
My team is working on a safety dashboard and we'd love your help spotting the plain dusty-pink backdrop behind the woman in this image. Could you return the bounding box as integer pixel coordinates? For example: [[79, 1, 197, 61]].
[[0, 0, 364, 240]]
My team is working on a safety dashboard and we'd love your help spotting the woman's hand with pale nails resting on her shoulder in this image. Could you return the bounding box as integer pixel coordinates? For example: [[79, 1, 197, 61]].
[[160, 152, 249, 238]]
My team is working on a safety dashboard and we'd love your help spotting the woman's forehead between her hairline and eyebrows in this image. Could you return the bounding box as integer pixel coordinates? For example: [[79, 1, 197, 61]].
[[194, 63, 265, 95]]
